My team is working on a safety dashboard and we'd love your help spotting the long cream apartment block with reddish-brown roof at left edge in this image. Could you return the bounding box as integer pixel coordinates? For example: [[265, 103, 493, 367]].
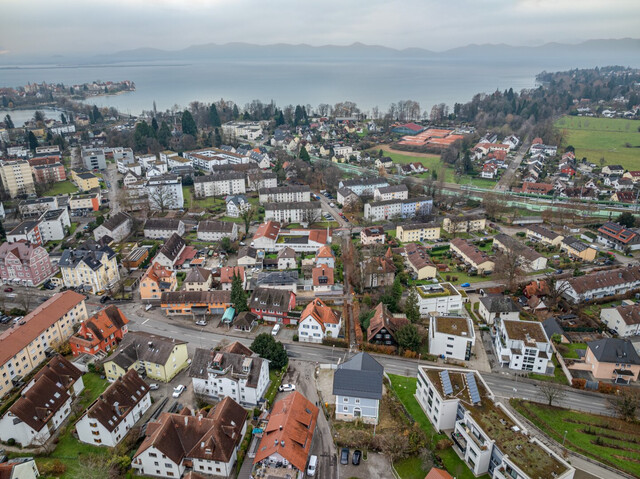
[[0, 291, 88, 397]]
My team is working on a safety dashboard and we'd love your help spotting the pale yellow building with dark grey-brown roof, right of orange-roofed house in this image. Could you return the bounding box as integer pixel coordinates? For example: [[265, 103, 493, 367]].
[[104, 331, 189, 382]]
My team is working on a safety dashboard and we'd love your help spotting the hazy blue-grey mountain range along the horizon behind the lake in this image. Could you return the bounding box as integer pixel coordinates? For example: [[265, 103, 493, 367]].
[[0, 38, 640, 68]]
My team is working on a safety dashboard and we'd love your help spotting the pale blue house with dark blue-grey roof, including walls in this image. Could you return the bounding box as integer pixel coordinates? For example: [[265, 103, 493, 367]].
[[333, 353, 384, 424]]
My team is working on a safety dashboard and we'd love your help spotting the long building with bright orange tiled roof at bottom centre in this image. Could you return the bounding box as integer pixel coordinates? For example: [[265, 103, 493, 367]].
[[253, 391, 319, 477]]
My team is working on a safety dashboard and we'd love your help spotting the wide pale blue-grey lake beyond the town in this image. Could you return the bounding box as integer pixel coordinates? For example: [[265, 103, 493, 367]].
[[0, 59, 552, 114]]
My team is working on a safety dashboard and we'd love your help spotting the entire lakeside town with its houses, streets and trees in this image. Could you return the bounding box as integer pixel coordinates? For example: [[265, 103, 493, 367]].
[[0, 67, 640, 479]]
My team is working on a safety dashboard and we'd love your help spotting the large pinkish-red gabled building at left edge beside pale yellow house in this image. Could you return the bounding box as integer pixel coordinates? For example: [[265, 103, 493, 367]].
[[0, 242, 56, 286]]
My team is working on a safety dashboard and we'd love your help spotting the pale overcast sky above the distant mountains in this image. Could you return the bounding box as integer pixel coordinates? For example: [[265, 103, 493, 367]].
[[0, 0, 640, 55]]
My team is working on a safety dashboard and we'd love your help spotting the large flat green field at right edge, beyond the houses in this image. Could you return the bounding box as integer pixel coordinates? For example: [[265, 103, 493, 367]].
[[555, 116, 640, 170]]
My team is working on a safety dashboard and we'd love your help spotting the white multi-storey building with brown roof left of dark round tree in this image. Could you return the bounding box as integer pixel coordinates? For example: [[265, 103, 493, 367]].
[[189, 342, 269, 407]]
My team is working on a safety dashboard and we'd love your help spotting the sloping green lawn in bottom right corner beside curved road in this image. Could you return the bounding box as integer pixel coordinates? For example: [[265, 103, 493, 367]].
[[511, 400, 640, 477]]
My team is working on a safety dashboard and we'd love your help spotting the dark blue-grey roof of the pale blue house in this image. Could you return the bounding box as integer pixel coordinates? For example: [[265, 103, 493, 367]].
[[333, 353, 384, 400]]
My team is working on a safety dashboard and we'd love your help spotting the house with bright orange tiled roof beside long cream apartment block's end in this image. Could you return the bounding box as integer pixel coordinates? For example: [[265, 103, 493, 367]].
[[69, 305, 129, 356]]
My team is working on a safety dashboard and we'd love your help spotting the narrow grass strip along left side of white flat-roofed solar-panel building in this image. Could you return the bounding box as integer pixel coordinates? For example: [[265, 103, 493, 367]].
[[389, 374, 489, 479]]
